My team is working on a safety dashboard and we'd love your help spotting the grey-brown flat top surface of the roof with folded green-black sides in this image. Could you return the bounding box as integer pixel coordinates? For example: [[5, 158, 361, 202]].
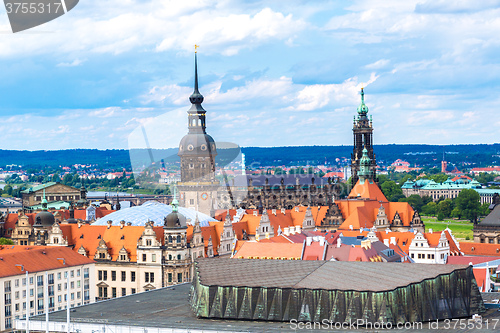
[[196, 258, 468, 292]]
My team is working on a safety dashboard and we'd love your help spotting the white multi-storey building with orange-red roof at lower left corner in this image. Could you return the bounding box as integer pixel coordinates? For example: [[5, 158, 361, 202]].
[[0, 245, 95, 331]]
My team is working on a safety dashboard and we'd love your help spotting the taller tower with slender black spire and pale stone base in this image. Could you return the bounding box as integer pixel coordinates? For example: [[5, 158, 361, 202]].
[[177, 52, 219, 216]]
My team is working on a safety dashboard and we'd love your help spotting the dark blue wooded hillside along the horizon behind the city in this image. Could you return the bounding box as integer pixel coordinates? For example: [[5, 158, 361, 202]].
[[0, 144, 500, 169]]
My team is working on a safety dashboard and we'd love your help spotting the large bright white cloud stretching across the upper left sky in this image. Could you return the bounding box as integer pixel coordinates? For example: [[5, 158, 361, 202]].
[[0, 0, 306, 57]]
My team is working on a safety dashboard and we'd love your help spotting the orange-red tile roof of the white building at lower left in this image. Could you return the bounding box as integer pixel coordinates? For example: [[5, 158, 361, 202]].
[[0, 245, 94, 277]]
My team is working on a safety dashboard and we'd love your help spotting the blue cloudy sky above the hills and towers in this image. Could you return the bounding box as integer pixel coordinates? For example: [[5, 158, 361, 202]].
[[0, 0, 500, 150]]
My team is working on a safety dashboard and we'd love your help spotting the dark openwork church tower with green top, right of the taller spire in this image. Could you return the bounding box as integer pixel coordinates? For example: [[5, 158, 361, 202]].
[[351, 88, 377, 186]]
